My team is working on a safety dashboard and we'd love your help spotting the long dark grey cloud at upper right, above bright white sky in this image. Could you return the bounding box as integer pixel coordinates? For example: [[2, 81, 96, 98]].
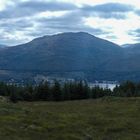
[[81, 3, 134, 19]]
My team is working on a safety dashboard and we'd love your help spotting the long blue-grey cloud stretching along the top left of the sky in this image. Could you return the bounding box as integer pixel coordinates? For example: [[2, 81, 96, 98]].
[[0, 1, 77, 19]]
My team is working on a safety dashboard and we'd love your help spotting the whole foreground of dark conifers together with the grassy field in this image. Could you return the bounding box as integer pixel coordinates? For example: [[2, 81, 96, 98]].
[[0, 81, 140, 140]]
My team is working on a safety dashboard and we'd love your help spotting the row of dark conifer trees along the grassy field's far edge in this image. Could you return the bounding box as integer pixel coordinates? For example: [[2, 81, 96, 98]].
[[0, 81, 140, 102]]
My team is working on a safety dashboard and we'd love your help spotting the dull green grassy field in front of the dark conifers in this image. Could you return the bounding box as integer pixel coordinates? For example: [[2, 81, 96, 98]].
[[0, 97, 140, 140]]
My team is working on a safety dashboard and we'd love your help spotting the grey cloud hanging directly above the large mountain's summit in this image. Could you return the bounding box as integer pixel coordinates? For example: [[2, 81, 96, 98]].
[[34, 11, 108, 35]]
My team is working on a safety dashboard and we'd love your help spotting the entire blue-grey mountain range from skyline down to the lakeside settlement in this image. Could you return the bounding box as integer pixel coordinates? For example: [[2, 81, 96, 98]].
[[0, 32, 140, 81]]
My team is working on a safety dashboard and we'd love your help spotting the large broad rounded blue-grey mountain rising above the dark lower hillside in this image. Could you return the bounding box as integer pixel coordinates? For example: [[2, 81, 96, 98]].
[[0, 32, 122, 72]]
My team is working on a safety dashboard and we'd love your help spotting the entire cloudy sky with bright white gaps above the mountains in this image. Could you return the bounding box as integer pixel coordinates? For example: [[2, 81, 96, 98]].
[[0, 0, 140, 45]]
